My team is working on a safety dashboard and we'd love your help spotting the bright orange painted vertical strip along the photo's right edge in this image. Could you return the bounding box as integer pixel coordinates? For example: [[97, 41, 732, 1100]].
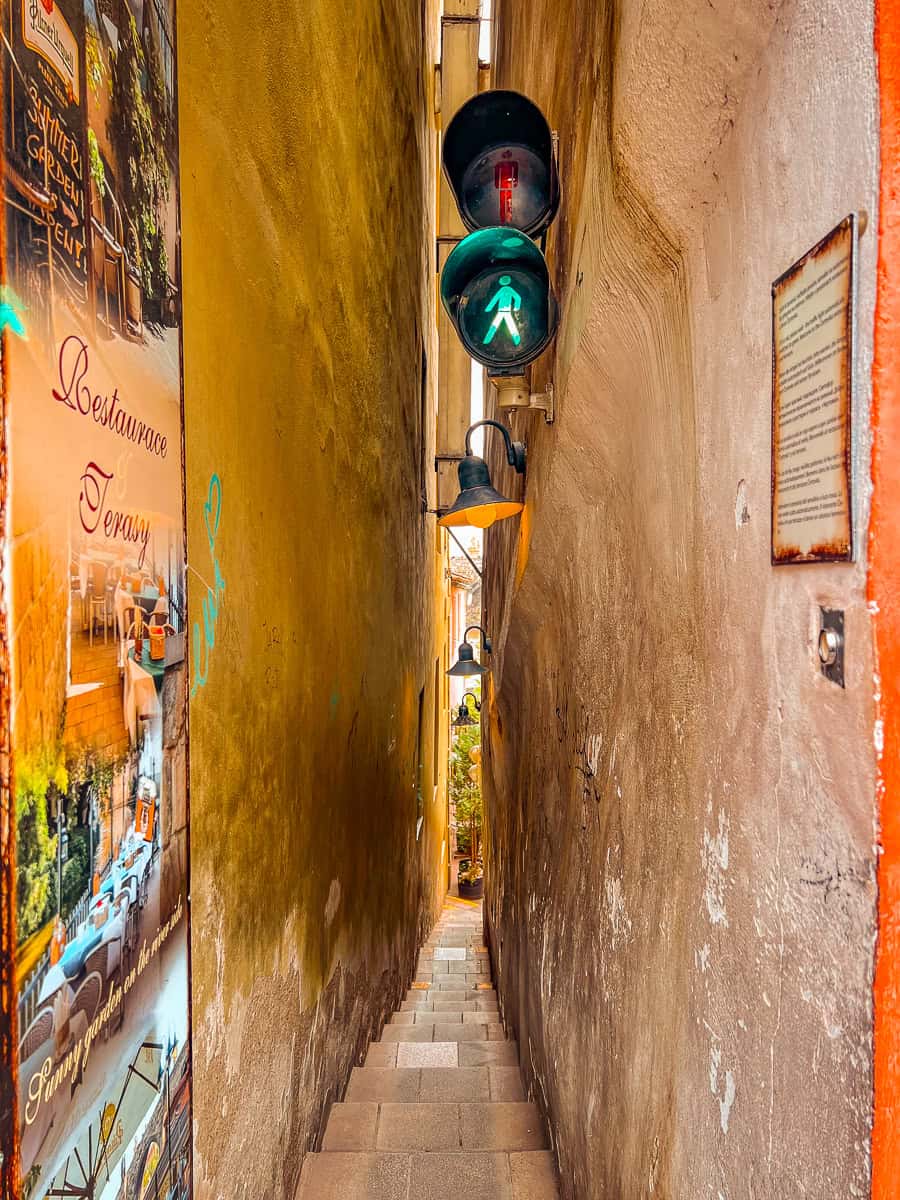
[[869, 0, 900, 1200]]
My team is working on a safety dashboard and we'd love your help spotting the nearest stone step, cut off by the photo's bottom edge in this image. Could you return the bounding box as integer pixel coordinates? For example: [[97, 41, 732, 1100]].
[[295, 1150, 559, 1200]]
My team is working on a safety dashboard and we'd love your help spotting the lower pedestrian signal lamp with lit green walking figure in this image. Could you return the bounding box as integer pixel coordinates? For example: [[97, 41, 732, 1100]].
[[440, 226, 558, 371]]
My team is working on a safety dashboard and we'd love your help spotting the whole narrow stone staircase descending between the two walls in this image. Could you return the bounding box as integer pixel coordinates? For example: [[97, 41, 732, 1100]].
[[296, 898, 558, 1200]]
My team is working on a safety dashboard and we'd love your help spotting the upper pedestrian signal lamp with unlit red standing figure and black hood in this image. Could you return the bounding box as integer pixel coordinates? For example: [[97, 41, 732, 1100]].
[[442, 90, 559, 238]]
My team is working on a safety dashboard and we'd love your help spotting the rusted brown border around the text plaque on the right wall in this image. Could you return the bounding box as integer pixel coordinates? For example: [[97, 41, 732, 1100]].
[[772, 212, 859, 566]]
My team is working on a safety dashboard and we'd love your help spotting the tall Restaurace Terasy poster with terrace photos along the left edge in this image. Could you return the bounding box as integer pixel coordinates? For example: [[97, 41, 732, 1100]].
[[0, 0, 191, 1200]]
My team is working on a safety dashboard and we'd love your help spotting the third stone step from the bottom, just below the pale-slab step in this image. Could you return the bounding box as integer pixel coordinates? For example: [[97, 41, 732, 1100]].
[[346, 1067, 526, 1104]]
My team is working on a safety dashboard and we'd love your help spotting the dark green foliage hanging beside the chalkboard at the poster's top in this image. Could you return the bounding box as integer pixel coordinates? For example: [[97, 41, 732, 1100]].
[[109, 2, 172, 301]]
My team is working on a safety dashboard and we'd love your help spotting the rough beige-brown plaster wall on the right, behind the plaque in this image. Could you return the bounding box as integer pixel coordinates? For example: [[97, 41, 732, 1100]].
[[485, 0, 877, 1200]]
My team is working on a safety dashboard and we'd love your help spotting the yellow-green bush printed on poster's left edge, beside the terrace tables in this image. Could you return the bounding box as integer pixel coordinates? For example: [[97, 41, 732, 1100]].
[[16, 745, 68, 942]]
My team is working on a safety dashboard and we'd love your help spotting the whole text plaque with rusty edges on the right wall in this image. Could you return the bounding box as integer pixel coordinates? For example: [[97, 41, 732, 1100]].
[[772, 214, 859, 565]]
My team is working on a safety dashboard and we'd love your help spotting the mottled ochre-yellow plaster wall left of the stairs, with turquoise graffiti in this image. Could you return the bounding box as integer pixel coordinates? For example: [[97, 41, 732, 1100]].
[[179, 0, 445, 1200]]
